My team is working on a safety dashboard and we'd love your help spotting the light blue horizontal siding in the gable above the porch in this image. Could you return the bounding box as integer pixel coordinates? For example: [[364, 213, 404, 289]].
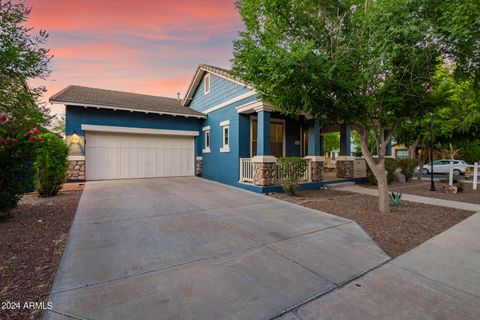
[[190, 73, 251, 111]]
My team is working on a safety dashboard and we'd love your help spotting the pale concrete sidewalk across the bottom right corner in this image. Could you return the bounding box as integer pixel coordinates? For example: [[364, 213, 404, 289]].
[[277, 213, 480, 320]]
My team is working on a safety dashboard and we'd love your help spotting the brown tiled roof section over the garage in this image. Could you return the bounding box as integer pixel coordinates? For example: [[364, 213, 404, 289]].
[[49, 85, 206, 118]]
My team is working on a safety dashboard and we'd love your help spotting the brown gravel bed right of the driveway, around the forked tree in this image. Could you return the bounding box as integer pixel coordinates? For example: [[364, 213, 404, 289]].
[[272, 190, 474, 258]]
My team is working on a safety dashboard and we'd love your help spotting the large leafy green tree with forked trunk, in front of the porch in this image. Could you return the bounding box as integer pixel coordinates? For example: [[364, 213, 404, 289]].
[[233, 0, 438, 212]]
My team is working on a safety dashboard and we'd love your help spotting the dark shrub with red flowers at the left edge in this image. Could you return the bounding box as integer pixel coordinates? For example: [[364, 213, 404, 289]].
[[0, 116, 42, 221]]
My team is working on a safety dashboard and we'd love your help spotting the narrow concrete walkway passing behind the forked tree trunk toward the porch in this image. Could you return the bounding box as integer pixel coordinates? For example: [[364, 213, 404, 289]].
[[336, 185, 480, 212]]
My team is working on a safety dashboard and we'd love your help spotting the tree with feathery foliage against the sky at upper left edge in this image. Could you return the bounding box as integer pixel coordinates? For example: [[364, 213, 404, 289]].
[[0, 0, 51, 128]]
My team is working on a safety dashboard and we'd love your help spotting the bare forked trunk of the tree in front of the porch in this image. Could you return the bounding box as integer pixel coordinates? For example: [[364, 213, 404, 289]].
[[359, 127, 390, 213]]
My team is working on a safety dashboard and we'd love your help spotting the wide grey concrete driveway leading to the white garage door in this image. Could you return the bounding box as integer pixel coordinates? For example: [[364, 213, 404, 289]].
[[46, 177, 388, 320]]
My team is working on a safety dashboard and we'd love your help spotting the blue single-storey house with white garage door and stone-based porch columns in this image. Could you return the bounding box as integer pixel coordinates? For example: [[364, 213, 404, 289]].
[[50, 65, 372, 192]]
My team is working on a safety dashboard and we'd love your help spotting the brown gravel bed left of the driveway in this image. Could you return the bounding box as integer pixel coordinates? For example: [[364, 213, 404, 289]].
[[0, 188, 82, 319]]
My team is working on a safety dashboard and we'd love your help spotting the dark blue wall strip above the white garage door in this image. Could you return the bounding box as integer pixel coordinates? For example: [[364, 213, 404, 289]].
[[65, 106, 203, 136]]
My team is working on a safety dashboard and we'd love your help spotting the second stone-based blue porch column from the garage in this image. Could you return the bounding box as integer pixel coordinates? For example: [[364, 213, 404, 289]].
[[304, 120, 325, 182]]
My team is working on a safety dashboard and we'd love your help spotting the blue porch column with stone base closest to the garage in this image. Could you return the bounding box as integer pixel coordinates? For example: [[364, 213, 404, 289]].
[[252, 104, 277, 186]]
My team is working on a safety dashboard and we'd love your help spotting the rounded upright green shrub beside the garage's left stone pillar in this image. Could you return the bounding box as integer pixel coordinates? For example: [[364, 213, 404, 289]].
[[35, 133, 68, 197]]
